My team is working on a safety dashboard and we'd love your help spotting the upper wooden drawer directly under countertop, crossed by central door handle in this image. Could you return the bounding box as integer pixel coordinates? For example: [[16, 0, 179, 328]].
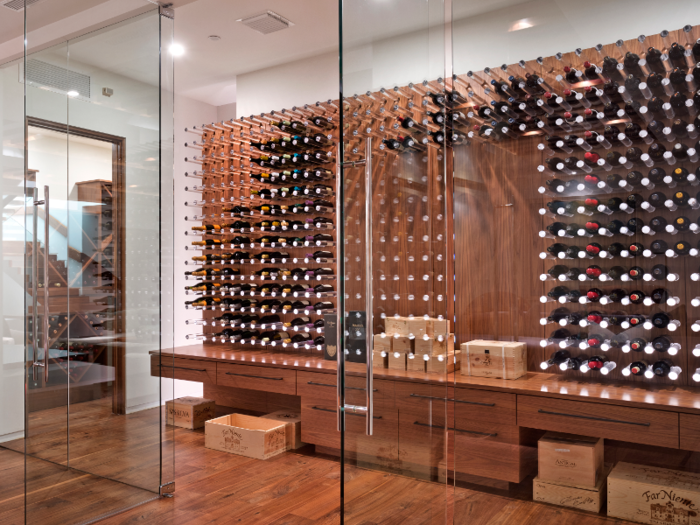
[[297, 371, 394, 409]]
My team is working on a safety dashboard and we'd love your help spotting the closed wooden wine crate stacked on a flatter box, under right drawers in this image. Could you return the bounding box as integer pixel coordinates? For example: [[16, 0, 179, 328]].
[[537, 432, 603, 489]]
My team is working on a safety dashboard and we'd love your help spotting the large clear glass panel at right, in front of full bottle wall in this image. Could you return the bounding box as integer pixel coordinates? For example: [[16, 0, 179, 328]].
[[450, 0, 700, 524]]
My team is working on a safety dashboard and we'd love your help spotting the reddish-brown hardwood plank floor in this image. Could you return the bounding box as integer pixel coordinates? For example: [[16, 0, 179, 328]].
[[0, 401, 640, 525]]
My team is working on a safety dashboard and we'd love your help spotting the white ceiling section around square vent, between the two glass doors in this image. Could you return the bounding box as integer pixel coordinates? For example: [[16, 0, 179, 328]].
[[175, 0, 338, 106]]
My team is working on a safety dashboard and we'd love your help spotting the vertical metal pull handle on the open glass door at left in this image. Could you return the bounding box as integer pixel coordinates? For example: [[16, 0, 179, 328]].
[[32, 186, 50, 382]]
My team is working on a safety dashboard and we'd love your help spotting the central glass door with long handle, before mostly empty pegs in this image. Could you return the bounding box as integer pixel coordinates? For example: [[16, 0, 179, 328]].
[[338, 0, 455, 523]]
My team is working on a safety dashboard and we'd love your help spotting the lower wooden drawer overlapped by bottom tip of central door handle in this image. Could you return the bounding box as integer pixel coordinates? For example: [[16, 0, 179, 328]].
[[301, 400, 398, 460]]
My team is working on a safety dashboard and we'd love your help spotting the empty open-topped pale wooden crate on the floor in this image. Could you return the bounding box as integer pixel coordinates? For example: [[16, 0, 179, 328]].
[[204, 414, 287, 459]]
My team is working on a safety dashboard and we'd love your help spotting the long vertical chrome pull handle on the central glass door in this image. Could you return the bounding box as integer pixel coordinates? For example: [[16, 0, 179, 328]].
[[365, 137, 374, 436]]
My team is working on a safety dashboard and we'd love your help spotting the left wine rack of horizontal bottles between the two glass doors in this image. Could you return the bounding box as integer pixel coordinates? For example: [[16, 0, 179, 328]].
[[183, 101, 338, 355]]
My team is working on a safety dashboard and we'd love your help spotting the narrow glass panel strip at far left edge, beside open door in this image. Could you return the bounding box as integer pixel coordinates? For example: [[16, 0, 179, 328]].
[[0, 5, 31, 523]]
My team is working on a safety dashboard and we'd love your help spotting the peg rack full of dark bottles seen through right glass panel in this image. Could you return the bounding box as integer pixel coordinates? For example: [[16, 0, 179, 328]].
[[455, 26, 700, 385]]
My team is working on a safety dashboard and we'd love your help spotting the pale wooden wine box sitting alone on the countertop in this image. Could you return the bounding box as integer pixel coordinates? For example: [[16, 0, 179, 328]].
[[460, 339, 527, 379]]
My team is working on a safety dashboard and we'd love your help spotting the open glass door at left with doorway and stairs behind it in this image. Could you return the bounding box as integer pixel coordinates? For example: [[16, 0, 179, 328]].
[[0, 2, 174, 524]]
